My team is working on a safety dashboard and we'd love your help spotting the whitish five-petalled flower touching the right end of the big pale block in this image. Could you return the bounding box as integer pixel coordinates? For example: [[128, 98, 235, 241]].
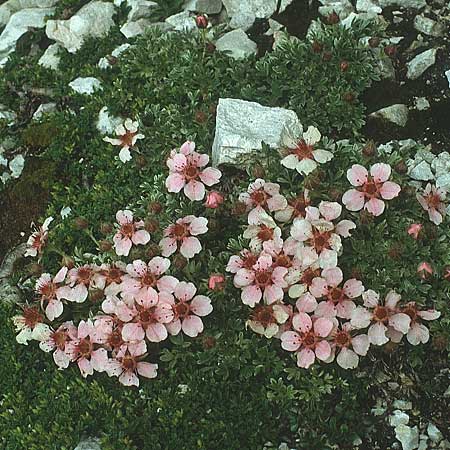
[[281, 125, 333, 175]]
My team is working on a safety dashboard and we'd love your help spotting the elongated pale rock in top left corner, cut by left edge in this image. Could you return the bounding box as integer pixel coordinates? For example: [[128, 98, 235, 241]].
[[0, 8, 54, 67]]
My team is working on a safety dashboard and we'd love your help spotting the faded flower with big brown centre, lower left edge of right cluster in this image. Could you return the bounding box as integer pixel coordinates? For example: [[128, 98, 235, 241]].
[[247, 304, 289, 339]]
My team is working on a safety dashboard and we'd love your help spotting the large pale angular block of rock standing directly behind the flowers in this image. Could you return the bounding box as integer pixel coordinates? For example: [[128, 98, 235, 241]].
[[212, 98, 299, 166]]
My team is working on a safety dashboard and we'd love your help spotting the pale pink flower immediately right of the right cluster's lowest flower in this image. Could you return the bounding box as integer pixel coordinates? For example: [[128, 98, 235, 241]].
[[327, 322, 370, 369]]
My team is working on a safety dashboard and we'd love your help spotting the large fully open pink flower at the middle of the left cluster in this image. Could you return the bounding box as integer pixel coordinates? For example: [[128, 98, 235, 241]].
[[116, 288, 174, 342]]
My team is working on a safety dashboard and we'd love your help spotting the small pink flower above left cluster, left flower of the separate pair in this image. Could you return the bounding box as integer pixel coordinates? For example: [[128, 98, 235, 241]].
[[113, 209, 150, 256]]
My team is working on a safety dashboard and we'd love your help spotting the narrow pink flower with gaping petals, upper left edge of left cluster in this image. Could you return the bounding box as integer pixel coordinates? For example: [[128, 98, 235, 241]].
[[35, 267, 70, 321]]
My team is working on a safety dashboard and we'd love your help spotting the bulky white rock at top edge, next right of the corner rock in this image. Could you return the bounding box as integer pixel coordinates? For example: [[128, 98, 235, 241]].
[[45, 1, 115, 53]]
